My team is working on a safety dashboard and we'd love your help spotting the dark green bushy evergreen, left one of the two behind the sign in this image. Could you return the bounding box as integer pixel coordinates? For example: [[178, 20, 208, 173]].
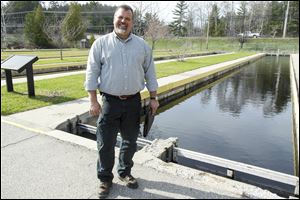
[[24, 5, 50, 47]]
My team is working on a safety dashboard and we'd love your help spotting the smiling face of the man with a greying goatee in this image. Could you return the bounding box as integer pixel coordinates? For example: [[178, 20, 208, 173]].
[[114, 8, 133, 39]]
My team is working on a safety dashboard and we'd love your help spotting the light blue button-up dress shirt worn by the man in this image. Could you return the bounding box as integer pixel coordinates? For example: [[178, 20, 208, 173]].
[[85, 32, 158, 96]]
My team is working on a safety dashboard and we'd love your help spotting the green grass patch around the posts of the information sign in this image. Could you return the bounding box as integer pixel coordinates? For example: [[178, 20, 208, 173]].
[[1, 74, 87, 115]]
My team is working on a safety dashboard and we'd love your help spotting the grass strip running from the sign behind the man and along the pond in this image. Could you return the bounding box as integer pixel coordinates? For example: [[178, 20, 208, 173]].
[[1, 52, 254, 115]]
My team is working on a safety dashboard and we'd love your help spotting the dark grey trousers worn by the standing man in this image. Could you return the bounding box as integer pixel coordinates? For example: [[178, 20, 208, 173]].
[[96, 93, 141, 181]]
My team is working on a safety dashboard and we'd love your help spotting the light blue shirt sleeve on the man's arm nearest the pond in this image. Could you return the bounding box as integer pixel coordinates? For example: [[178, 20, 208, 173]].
[[143, 44, 158, 92]]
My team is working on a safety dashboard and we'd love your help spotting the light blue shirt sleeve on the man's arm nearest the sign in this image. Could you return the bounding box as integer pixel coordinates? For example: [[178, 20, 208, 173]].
[[84, 39, 101, 91]]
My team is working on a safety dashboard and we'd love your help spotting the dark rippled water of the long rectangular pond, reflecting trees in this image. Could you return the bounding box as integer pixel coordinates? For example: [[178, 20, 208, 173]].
[[147, 56, 293, 174]]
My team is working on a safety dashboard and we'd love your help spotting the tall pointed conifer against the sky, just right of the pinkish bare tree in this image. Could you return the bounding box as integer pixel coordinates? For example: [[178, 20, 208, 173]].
[[169, 1, 188, 37]]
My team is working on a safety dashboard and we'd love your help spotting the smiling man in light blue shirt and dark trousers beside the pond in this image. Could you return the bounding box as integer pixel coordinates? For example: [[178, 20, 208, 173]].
[[85, 5, 159, 198]]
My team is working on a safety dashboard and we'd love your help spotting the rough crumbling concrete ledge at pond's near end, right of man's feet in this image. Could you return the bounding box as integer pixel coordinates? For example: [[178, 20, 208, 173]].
[[134, 138, 283, 199]]
